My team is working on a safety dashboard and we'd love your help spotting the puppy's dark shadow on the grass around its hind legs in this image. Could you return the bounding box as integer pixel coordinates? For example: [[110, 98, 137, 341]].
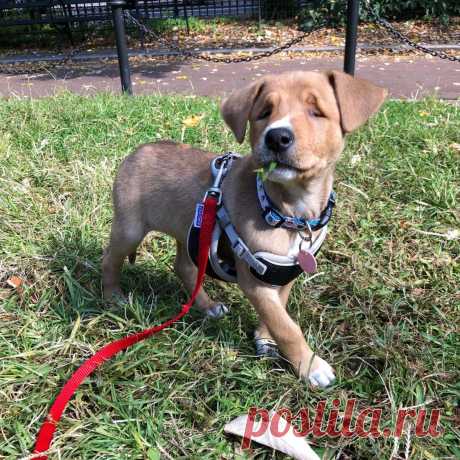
[[39, 234, 254, 342]]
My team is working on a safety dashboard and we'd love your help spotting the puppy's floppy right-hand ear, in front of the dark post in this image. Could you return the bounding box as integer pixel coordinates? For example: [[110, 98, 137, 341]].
[[328, 70, 388, 133]]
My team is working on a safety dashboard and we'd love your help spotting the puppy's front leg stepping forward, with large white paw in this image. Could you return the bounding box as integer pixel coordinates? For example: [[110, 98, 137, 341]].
[[240, 277, 335, 387]]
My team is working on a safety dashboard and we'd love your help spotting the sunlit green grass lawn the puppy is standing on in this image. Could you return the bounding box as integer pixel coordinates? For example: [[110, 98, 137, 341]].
[[0, 94, 460, 460]]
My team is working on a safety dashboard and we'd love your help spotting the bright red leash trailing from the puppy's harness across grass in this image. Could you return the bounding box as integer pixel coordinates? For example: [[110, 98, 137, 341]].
[[34, 194, 218, 460]]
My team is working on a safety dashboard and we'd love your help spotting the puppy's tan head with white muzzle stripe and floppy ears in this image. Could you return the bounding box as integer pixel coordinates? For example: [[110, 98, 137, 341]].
[[221, 71, 387, 182]]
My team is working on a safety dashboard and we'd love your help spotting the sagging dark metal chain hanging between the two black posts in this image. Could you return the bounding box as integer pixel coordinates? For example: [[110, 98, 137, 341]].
[[124, 10, 325, 64]]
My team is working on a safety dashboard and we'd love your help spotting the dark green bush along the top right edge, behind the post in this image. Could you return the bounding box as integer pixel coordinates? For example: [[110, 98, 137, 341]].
[[300, 0, 460, 29]]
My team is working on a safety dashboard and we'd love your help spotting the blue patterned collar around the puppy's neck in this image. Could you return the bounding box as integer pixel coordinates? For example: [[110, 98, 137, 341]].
[[257, 174, 336, 232]]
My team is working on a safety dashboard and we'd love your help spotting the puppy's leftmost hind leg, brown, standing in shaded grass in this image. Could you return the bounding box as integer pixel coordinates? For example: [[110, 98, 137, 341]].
[[102, 220, 145, 300]]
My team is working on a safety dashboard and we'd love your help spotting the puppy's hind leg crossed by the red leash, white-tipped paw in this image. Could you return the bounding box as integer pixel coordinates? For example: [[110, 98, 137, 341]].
[[174, 241, 228, 318]]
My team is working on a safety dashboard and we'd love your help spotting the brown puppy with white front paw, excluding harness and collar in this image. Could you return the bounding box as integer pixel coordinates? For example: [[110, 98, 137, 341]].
[[103, 71, 386, 386]]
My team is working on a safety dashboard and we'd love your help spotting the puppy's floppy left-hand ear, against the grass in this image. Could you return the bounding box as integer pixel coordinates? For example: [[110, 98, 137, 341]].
[[220, 79, 264, 144]]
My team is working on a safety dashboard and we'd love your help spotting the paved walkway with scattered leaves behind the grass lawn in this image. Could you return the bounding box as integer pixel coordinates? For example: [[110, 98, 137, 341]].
[[0, 56, 460, 100]]
